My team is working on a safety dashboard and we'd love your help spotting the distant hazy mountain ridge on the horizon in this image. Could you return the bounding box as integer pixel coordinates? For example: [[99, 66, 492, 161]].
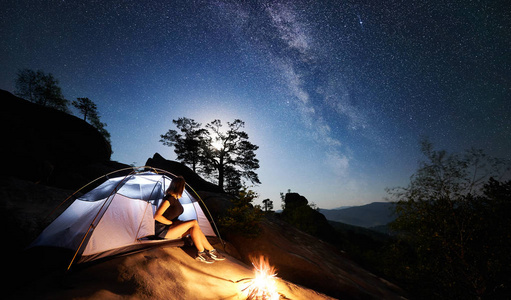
[[319, 202, 395, 228]]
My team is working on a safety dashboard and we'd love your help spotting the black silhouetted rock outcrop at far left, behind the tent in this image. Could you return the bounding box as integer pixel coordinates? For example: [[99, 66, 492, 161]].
[[0, 90, 125, 189]]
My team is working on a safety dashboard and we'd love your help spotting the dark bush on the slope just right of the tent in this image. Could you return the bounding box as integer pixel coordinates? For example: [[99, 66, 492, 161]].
[[218, 186, 263, 236]]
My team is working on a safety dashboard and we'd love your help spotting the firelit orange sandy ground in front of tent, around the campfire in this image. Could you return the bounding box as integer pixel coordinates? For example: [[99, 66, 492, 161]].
[[10, 247, 332, 300]]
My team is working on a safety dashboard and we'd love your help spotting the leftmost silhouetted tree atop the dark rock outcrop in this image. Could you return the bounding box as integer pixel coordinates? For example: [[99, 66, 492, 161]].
[[15, 69, 69, 113]]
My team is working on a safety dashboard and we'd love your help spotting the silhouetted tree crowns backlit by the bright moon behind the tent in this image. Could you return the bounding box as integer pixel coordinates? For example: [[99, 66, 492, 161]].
[[160, 118, 260, 194]]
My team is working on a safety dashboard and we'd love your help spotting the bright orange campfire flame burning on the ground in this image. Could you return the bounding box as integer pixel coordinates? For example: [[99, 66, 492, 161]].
[[243, 256, 280, 300]]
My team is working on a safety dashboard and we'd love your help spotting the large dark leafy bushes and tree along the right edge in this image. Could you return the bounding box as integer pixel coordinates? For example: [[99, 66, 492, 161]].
[[389, 142, 511, 299]]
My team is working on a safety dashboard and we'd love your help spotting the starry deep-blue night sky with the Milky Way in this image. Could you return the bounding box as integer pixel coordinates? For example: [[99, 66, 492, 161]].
[[0, 0, 511, 209]]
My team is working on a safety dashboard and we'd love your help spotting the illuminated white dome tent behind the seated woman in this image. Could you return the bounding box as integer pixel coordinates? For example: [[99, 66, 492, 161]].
[[31, 169, 216, 267]]
